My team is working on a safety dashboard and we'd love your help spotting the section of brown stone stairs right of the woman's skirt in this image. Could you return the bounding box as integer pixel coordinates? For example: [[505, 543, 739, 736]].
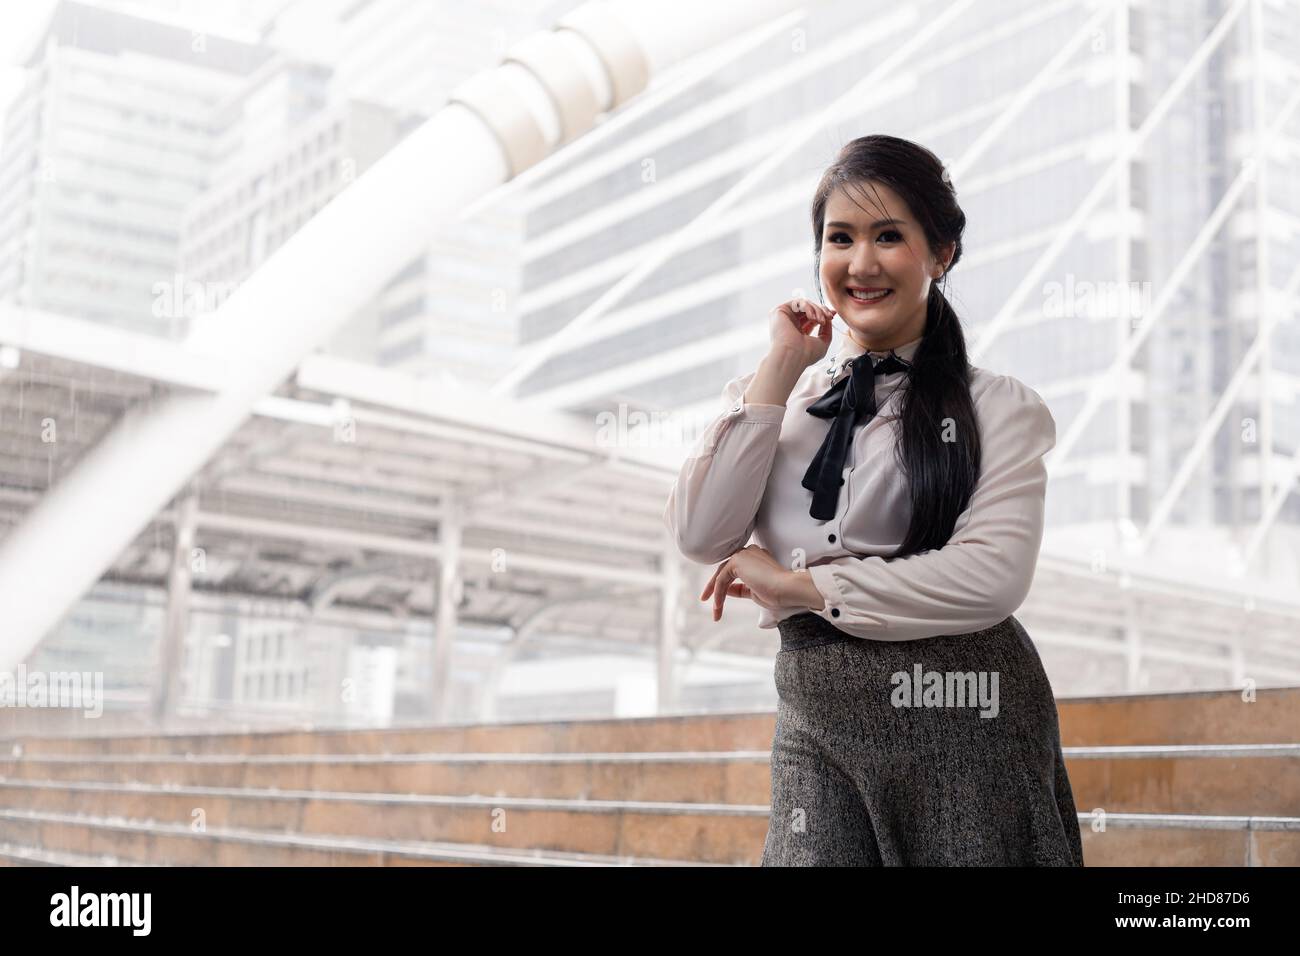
[[1058, 688, 1300, 866]]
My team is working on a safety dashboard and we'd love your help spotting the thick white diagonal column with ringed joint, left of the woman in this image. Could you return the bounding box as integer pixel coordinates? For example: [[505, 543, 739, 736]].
[[0, 0, 798, 670]]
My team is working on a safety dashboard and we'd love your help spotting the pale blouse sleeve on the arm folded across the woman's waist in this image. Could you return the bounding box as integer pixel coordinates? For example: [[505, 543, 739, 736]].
[[809, 375, 1056, 641]]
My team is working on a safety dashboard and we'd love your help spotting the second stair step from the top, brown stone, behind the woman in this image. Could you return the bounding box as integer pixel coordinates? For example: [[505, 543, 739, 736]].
[[0, 744, 1300, 816]]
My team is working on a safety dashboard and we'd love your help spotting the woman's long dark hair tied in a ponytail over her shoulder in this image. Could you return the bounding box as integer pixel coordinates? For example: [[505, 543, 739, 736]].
[[813, 135, 980, 558]]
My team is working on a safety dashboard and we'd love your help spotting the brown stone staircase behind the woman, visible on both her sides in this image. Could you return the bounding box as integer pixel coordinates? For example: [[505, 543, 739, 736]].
[[0, 688, 1300, 866]]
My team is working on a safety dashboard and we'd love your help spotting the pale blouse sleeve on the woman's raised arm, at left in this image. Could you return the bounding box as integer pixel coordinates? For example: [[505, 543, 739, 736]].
[[663, 372, 785, 564]]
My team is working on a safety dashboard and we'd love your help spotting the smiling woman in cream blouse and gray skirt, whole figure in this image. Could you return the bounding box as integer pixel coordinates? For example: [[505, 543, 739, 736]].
[[664, 135, 1083, 866]]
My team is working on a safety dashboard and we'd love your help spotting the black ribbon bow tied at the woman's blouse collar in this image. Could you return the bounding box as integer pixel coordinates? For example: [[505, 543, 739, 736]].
[[802, 352, 910, 522]]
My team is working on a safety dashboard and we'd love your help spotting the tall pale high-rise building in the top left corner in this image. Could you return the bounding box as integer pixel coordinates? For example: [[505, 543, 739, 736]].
[[0, 0, 269, 338]]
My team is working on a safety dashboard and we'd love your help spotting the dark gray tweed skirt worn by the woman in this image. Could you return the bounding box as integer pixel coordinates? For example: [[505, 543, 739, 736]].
[[762, 613, 1083, 866]]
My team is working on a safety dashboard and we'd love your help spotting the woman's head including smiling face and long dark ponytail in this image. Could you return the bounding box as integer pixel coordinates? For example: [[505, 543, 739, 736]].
[[813, 135, 980, 557]]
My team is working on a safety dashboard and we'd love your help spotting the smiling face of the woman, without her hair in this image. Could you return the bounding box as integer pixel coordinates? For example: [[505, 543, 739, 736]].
[[820, 182, 953, 351]]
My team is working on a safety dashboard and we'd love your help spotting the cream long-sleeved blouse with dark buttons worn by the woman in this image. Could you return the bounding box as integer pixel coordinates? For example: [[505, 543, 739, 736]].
[[664, 330, 1056, 641]]
